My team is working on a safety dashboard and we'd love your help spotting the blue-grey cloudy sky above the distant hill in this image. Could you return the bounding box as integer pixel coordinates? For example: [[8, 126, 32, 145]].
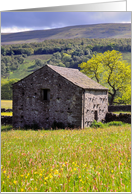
[[1, 12, 131, 33]]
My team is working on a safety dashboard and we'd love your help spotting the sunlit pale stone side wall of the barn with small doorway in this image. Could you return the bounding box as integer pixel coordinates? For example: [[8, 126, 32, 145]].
[[84, 90, 108, 127]]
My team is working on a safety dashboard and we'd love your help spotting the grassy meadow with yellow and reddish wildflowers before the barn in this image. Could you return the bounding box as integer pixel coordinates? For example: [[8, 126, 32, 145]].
[[1, 124, 131, 192]]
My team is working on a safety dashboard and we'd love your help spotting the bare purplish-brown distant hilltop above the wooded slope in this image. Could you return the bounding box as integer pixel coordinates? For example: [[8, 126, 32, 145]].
[[1, 23, 131, 45]]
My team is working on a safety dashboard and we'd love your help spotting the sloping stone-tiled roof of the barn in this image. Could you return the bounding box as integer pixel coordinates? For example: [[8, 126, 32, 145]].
[[47, 65, 108, 90]]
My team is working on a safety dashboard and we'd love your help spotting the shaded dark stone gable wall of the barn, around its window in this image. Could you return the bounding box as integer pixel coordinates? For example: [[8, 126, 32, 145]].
[[13, 67, 82, 128]]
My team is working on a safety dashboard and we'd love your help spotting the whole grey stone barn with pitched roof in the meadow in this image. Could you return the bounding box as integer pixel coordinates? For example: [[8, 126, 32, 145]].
[[13, 65, 108, 128]]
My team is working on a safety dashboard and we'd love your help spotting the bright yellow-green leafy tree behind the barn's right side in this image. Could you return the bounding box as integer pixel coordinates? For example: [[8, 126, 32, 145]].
[[79, 50, 131, 105]]
